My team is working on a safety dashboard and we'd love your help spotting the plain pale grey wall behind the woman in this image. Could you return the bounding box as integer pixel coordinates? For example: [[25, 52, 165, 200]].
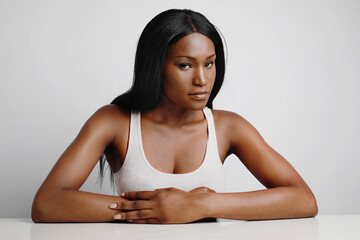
[[0, 0, 360, 217]]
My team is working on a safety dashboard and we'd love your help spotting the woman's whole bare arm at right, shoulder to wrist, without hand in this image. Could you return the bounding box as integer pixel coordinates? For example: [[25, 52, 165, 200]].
[[198, 112, 318, 220]]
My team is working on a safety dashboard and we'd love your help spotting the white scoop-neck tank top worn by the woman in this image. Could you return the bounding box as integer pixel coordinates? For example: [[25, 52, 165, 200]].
[[114, 108, 225, 194]]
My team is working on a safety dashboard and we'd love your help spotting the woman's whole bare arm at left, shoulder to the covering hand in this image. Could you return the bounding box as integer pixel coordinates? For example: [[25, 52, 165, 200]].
[[31, 106, 128, 222]]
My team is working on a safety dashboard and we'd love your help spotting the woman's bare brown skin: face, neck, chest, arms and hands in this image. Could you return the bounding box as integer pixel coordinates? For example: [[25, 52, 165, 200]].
[[32, 33, 317, 223]]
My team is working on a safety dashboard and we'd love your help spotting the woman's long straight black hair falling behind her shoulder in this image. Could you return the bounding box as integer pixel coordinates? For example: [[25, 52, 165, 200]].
[[100, 9, 225, 182]]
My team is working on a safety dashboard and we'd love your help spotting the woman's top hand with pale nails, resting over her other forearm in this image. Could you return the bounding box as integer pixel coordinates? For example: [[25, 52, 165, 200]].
[[110, 188, 205, 223]]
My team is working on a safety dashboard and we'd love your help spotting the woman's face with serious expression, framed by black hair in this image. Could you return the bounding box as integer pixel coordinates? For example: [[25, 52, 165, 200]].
[[162, 33, 216, 110]]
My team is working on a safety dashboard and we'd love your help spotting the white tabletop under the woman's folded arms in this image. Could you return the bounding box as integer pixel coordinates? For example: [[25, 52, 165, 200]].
[[0, 215, 360, 240]]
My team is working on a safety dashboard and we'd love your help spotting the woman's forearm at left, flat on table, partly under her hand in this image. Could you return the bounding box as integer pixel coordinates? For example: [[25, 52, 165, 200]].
[[31, 189, 124, 222]]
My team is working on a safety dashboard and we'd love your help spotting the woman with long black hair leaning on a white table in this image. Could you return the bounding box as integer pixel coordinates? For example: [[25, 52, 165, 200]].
[[32, 10, 317, 223]]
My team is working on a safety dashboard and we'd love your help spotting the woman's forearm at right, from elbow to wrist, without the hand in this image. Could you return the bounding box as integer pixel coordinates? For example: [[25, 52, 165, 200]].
[[198, 187, 317, 220]]
